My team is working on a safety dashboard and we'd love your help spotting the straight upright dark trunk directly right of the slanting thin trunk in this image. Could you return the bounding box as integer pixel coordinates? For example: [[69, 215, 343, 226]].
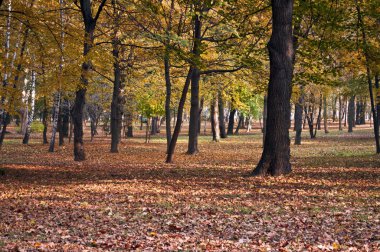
[[187, 15, 202, 154]]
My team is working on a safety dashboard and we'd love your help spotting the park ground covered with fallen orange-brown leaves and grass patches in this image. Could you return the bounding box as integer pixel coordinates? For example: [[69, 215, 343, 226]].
[[0, 128, 380, 251]]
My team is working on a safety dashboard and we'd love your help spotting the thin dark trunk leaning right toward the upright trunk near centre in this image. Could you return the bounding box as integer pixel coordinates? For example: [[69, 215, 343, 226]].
[[166, 68, 192, 163]]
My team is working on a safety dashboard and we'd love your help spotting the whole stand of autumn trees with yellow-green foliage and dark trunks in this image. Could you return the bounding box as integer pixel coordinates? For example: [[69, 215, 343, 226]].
[[0, 0, 380, 176]]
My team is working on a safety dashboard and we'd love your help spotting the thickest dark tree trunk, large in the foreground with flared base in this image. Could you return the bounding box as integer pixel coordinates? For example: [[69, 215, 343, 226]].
[[252, 0, 294, 176]]
